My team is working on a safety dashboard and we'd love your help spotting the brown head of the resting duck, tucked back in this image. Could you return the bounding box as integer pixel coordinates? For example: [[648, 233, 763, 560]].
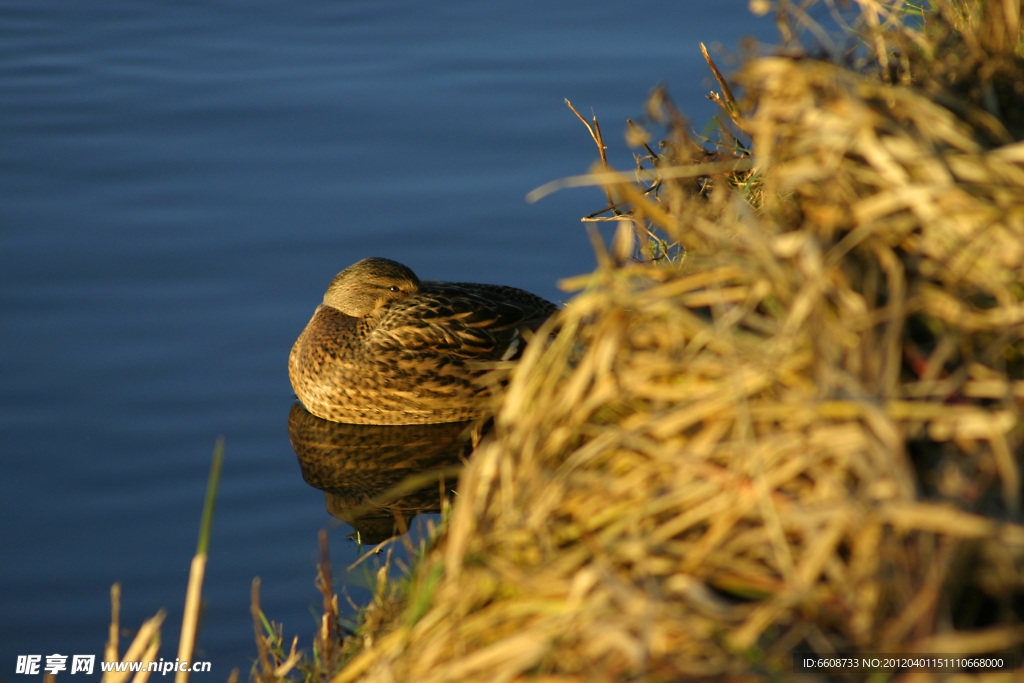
[[324, 258, 420, 317]]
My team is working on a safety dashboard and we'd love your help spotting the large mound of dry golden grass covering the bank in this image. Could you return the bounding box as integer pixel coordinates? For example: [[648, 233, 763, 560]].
[[276, 0, 1024, 683]]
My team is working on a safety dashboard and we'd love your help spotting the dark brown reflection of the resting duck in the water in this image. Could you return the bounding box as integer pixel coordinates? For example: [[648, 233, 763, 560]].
[[288, 403, 479, 545]]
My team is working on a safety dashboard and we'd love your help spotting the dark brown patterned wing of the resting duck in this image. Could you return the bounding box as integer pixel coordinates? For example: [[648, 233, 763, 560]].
[[371, 283, 557, 360]]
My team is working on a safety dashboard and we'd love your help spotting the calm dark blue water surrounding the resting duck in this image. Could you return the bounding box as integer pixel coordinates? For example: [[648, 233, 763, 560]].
[[0, 0, 774, 681]]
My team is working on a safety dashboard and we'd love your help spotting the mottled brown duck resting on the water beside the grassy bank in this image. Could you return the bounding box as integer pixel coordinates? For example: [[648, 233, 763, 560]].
[[288, 257, 558, 425]]
